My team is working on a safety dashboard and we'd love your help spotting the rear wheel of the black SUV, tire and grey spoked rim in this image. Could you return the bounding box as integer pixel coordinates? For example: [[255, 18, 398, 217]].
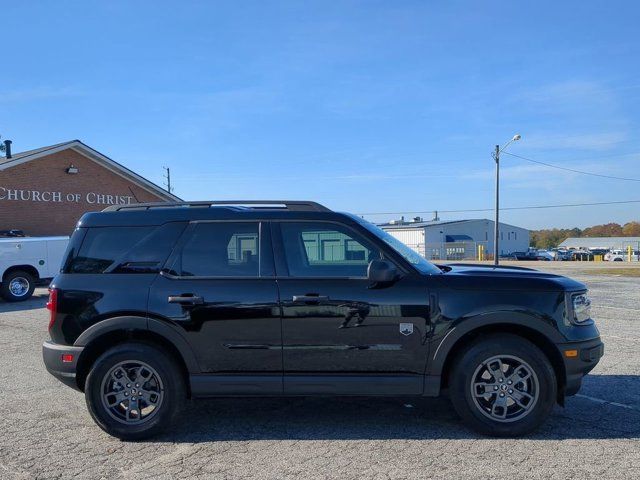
[[85, 343, 186, 440]]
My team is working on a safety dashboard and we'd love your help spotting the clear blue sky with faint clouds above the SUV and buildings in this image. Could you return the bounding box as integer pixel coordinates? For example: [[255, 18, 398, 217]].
[[0, 0, 640, 228]]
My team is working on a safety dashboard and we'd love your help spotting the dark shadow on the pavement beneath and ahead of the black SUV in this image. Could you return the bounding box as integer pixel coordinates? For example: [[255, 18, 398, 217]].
[[154, 375, 640, 443]]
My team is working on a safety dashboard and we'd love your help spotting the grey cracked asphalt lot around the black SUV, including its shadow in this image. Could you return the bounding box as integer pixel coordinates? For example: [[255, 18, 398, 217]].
[[0, 264, 640, 480]]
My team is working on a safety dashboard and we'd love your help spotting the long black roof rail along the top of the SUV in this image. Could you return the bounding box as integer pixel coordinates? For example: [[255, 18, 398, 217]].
[[102, 200, 331, 212]]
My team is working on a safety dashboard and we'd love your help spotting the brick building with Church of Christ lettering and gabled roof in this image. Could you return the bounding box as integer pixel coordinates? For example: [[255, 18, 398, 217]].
[[0, 140, 180, 236]]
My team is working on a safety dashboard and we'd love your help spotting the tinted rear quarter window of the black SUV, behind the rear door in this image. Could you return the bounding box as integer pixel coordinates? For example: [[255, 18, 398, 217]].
[[65, 227, 155, 273]]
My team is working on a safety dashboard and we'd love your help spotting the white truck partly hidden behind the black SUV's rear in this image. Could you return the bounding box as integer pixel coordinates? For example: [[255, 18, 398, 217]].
[[0, 237, 69, 302]]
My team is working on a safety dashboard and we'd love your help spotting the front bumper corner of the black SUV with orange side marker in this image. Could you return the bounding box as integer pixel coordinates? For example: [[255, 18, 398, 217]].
[[558, 337, 604, 396]]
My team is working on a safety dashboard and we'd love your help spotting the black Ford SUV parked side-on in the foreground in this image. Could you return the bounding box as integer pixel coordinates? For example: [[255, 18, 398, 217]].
[[43, 201, 603, 439]]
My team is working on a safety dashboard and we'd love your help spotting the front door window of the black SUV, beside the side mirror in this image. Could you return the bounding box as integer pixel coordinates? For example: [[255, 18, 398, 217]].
[[280, 222, 381, 277]]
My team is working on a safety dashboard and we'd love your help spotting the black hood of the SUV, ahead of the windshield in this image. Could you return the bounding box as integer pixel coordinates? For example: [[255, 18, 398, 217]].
[[437, 264, 587, 292]]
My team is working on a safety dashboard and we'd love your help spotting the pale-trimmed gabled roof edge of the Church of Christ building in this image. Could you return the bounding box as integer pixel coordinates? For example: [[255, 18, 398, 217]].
[[0, 140, 180, 201]]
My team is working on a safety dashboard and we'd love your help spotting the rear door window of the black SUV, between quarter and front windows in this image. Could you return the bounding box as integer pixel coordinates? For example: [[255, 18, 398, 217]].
[[173, 222, 260, 277]]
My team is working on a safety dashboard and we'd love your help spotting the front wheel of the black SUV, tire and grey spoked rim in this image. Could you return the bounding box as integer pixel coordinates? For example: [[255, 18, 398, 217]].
[[449, 334, 558, 437]]
